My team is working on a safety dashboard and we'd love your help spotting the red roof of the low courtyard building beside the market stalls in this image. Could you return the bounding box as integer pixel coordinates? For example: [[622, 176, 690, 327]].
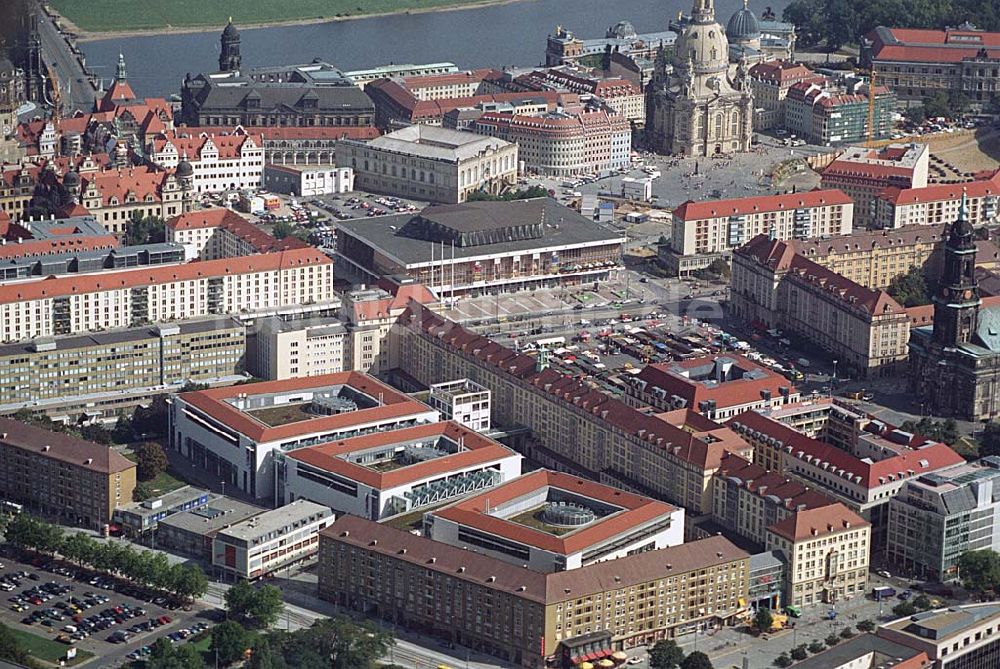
[[635, 353, 797, 411]]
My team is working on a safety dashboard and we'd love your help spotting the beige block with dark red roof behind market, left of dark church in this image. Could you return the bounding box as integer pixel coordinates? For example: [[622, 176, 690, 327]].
[[730, 235, 910, 377]]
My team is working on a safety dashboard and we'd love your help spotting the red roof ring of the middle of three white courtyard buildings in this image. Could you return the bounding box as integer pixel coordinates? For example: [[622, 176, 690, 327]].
[[288, 421, 516, 490]]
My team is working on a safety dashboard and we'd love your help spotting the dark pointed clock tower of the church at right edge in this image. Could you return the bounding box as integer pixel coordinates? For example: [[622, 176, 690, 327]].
[[934, 188, 982, 346]]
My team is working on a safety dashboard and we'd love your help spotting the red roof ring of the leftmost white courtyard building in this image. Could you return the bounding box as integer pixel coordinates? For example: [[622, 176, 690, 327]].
[[179, 370, 430, 443]]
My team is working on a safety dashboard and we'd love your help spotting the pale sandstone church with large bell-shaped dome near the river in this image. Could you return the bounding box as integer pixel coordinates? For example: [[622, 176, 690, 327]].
[[646, 0, 753, 156]]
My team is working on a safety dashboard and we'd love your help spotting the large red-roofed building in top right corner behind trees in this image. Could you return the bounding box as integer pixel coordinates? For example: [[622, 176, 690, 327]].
[[861, 23, 1000, 109]]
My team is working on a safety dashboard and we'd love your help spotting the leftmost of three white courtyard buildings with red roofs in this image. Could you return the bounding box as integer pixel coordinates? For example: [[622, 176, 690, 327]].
[[170, 372, 438, 501]]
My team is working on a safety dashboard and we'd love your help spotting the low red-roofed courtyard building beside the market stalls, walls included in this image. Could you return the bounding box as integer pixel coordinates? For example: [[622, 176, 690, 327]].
[[626, 355, 800, 422]]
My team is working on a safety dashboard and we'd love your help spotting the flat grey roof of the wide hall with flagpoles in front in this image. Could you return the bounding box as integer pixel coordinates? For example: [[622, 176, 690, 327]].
[[334, 198, 625, 265]]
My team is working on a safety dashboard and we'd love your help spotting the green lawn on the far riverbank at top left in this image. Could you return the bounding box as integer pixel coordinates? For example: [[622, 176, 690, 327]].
[[49, 0, 504, 32]]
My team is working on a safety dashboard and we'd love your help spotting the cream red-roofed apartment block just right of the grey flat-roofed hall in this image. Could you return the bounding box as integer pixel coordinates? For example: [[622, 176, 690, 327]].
[[660, 189, 854, 276]]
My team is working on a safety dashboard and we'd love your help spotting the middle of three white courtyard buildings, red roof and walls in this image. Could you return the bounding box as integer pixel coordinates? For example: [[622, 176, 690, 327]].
[[276, 421, 521, 520]]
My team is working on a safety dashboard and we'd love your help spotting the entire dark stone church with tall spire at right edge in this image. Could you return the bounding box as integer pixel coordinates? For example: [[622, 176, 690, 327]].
[[910, 194, 1000, 420]]
